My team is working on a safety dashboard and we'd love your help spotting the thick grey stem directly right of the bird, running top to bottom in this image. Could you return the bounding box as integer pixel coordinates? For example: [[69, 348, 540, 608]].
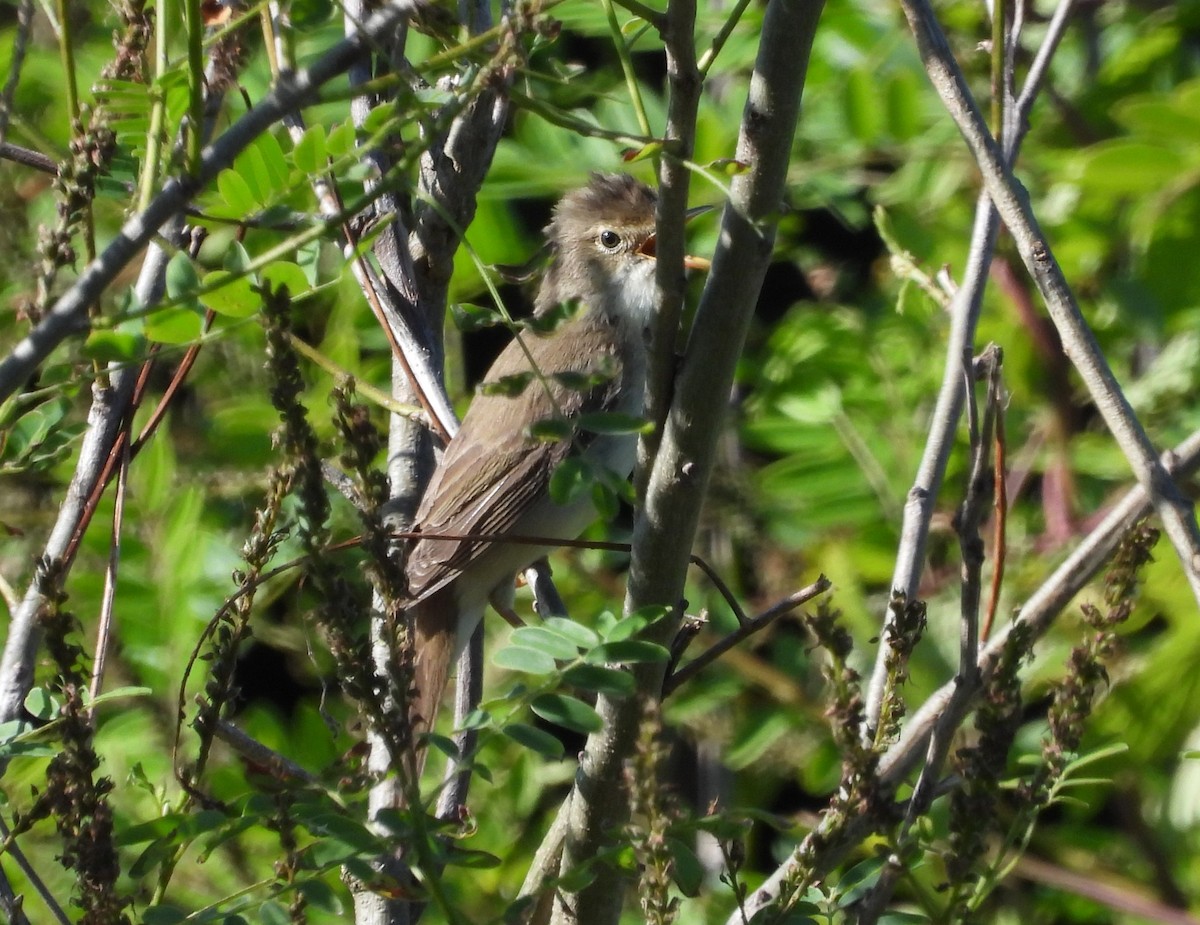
[[552, 0, 822, 925]]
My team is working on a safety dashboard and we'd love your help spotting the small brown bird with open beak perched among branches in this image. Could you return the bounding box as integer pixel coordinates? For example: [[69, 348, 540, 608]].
[[404, 173, 707, 763]]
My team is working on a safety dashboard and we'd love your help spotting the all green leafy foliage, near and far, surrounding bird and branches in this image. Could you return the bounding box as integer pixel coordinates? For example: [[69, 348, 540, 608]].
[[0, 0, 1200, 923]]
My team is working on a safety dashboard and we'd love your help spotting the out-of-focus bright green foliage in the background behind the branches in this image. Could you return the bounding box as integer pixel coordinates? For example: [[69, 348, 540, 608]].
[[0, 0, 1200, 923]]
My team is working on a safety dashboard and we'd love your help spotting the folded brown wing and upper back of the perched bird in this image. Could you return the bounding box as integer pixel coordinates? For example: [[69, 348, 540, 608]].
[[406, 316, 623, 599]]
